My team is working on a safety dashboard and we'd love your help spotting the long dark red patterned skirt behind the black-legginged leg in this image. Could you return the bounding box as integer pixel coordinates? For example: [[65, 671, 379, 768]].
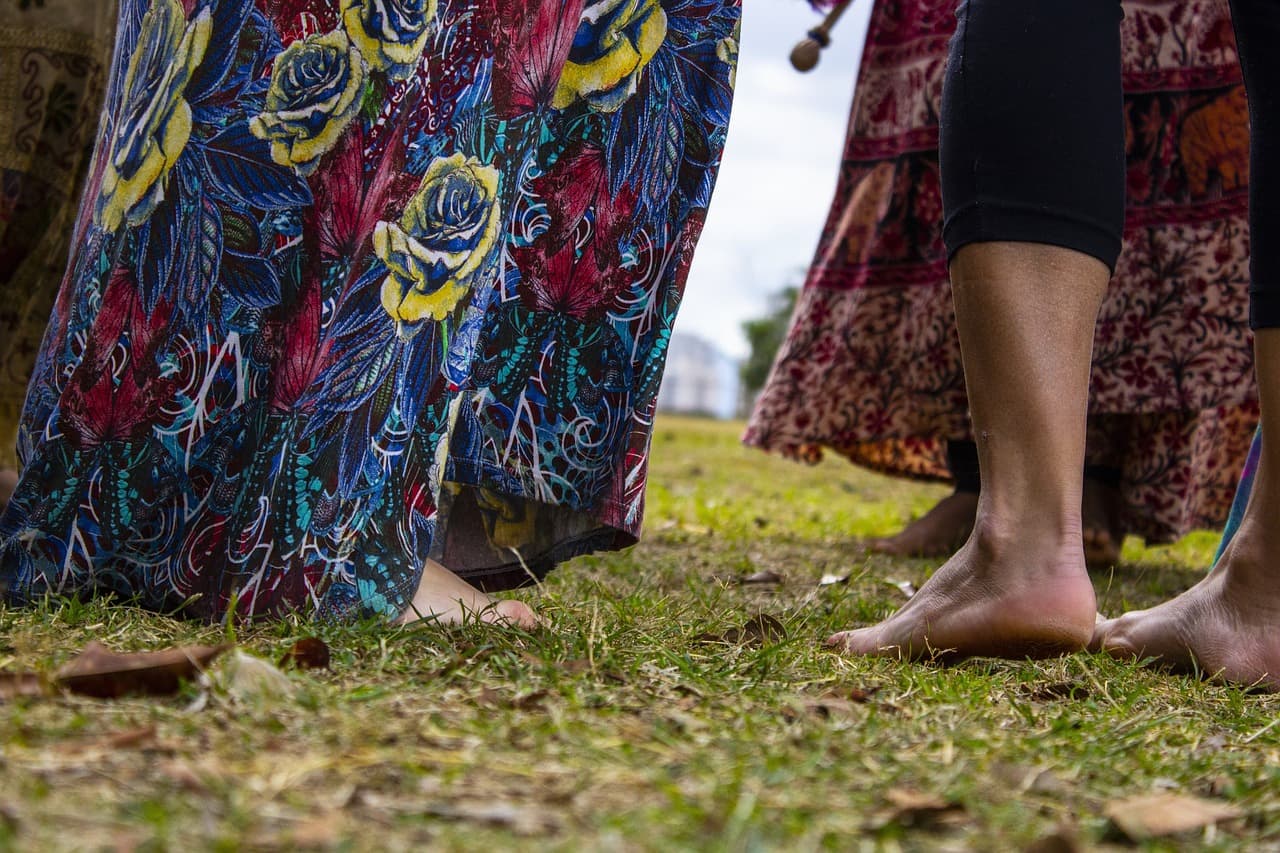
[[746, 0, 1257, 542]]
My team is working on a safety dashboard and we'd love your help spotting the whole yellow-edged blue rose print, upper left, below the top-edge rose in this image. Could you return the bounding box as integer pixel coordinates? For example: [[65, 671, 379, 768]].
[[248, 29, 365, 174]]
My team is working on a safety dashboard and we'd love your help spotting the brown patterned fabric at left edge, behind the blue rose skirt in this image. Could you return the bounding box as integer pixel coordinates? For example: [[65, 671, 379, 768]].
[[0, 0, 115, 470]]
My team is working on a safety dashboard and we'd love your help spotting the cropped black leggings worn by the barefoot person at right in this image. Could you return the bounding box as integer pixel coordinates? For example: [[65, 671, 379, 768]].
[[941, 0, 1280, 329]]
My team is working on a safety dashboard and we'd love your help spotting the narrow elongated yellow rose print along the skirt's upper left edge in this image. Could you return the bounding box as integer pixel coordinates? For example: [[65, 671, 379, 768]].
[[95, 0, 212, 231]]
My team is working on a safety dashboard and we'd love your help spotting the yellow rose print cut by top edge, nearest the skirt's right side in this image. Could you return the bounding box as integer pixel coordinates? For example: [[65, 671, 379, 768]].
[[552, 0, 667, 113]]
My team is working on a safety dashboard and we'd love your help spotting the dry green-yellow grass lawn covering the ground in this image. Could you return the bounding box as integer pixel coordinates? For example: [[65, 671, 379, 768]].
[[0, 409, 1280, 850]]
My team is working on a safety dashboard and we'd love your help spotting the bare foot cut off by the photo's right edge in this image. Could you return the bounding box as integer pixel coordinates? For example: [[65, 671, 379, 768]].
[[1091, 528, 1280, 690]]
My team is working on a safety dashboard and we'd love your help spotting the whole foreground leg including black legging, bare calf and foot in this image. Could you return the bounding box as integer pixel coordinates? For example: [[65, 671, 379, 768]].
[[831, 0, 1124, 657]]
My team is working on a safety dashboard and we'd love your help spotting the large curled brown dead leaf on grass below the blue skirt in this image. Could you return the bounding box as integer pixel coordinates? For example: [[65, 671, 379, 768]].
[[52, 642, 229, 699]]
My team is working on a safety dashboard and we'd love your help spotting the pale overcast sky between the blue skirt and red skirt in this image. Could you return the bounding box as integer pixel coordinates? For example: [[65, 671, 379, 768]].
[[676, 0, 870, 357]]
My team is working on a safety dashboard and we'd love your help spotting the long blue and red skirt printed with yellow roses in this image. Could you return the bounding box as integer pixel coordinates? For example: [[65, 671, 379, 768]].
[[0, 0, 740, 619]]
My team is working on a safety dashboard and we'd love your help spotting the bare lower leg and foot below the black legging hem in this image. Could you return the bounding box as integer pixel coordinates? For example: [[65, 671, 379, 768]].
[[832, 243, 1107, 657]]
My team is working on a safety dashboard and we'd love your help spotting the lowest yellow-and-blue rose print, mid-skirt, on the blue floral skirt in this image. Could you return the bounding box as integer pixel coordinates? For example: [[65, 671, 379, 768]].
[[374, 154, 499, 336]]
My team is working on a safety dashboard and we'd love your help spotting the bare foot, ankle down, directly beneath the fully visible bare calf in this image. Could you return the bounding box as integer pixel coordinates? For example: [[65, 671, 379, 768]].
[[827, 533, 1096, 660]]
